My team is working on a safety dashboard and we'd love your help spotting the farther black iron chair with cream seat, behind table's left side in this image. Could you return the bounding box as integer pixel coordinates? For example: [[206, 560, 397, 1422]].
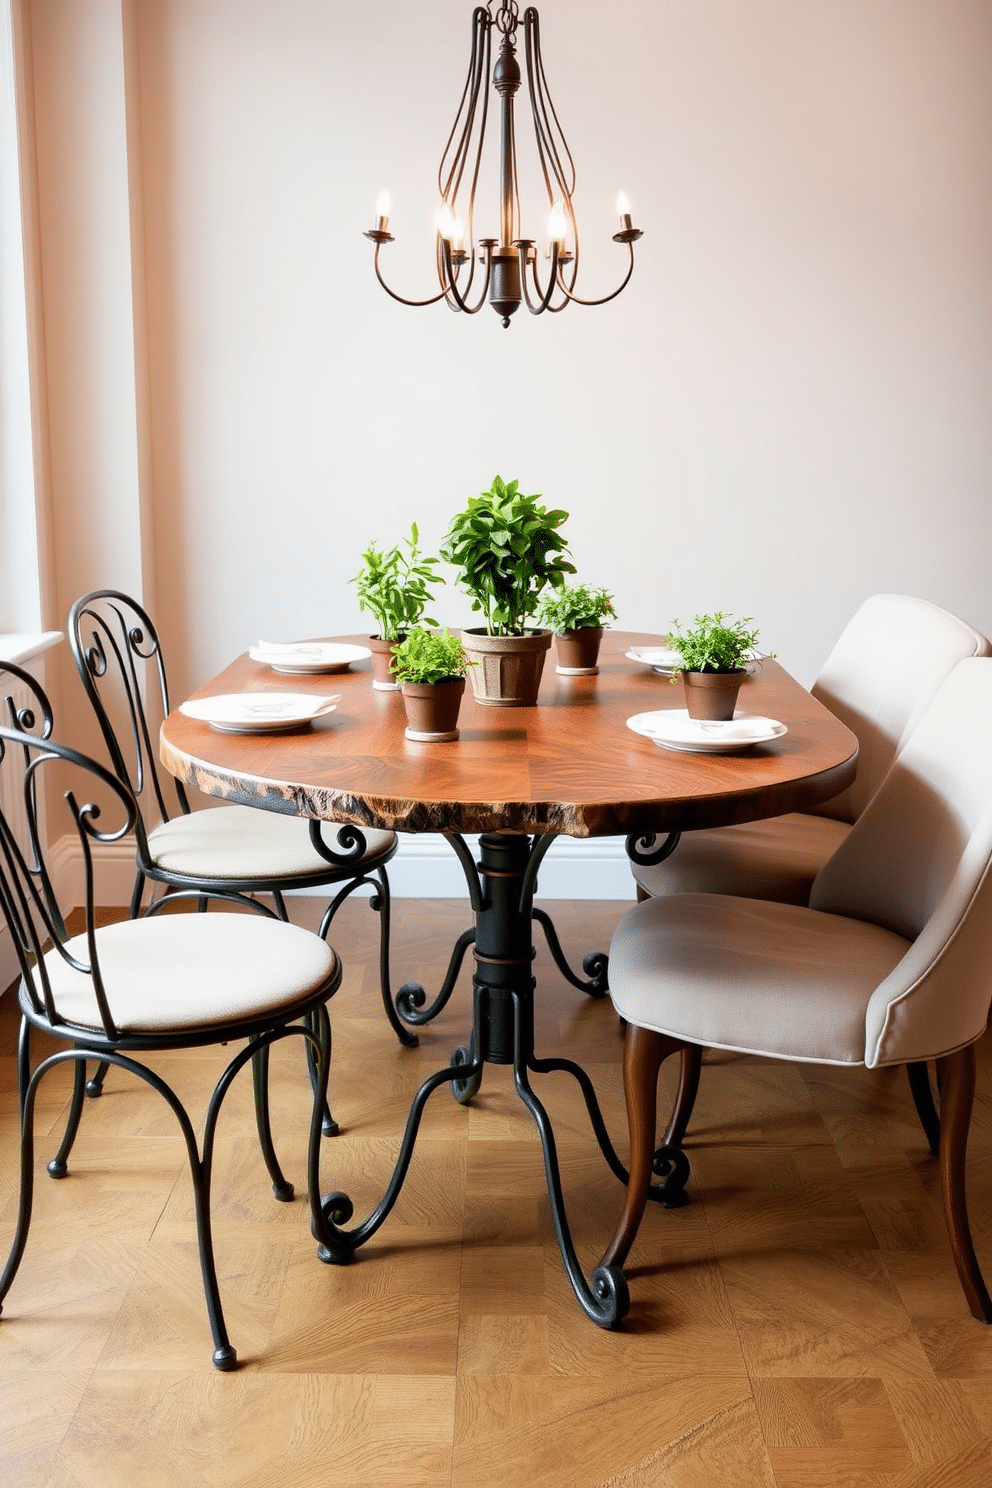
[[68, 589, 416, 1065]]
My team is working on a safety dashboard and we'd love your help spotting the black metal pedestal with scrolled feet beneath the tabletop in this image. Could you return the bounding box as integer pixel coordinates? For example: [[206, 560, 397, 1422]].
[[314, 832, 651, 1327]]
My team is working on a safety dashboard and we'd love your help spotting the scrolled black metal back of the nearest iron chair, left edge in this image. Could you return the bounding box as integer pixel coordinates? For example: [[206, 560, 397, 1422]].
[[0, 705, 138, 1037]]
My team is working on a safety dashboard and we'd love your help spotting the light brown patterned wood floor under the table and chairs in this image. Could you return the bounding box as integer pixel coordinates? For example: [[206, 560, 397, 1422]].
[[0, 900, 992, 1488]]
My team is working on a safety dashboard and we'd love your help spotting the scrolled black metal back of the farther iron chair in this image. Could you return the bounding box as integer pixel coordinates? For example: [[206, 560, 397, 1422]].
[[68, 589, 189, 839]]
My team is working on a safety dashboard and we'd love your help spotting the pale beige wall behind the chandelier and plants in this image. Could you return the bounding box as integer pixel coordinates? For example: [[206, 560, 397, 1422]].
[[15, 0, 992, 738]]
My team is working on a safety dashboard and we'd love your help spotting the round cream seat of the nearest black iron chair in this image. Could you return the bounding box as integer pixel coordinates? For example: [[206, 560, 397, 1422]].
[[45, 914, 335, 1034]]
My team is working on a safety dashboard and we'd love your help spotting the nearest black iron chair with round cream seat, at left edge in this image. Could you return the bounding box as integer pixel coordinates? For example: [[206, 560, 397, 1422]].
[[0, 665, 341, 1369]]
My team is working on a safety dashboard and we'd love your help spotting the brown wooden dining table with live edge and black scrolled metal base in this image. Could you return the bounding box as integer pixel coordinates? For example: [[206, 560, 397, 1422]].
[[161, 631, 858, 1327]]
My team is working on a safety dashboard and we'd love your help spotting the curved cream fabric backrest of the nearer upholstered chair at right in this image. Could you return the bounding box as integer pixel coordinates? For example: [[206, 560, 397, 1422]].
[[809, 658, 992, 1065]]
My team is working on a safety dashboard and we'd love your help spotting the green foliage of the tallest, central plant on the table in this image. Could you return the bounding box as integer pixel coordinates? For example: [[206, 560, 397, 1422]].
[[440, 476, 576, 635]]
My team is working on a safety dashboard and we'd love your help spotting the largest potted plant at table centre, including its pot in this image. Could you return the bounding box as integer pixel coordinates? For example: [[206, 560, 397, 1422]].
[[440, 476, 576, 708]]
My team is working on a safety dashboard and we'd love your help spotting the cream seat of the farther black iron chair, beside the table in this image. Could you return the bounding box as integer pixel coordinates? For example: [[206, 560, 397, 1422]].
[[147, 805, 396, 882]]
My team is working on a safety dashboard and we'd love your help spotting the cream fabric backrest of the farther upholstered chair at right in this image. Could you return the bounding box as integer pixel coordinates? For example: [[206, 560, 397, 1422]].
[[811, 594, 992, 821]]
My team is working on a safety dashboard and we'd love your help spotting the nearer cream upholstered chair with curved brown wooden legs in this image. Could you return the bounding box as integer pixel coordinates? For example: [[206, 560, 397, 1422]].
[[604, 658, 992, 1323]]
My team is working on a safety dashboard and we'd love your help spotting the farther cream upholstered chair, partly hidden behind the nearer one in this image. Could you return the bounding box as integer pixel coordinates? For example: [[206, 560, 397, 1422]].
[[632, 594, 992, 1150]]
